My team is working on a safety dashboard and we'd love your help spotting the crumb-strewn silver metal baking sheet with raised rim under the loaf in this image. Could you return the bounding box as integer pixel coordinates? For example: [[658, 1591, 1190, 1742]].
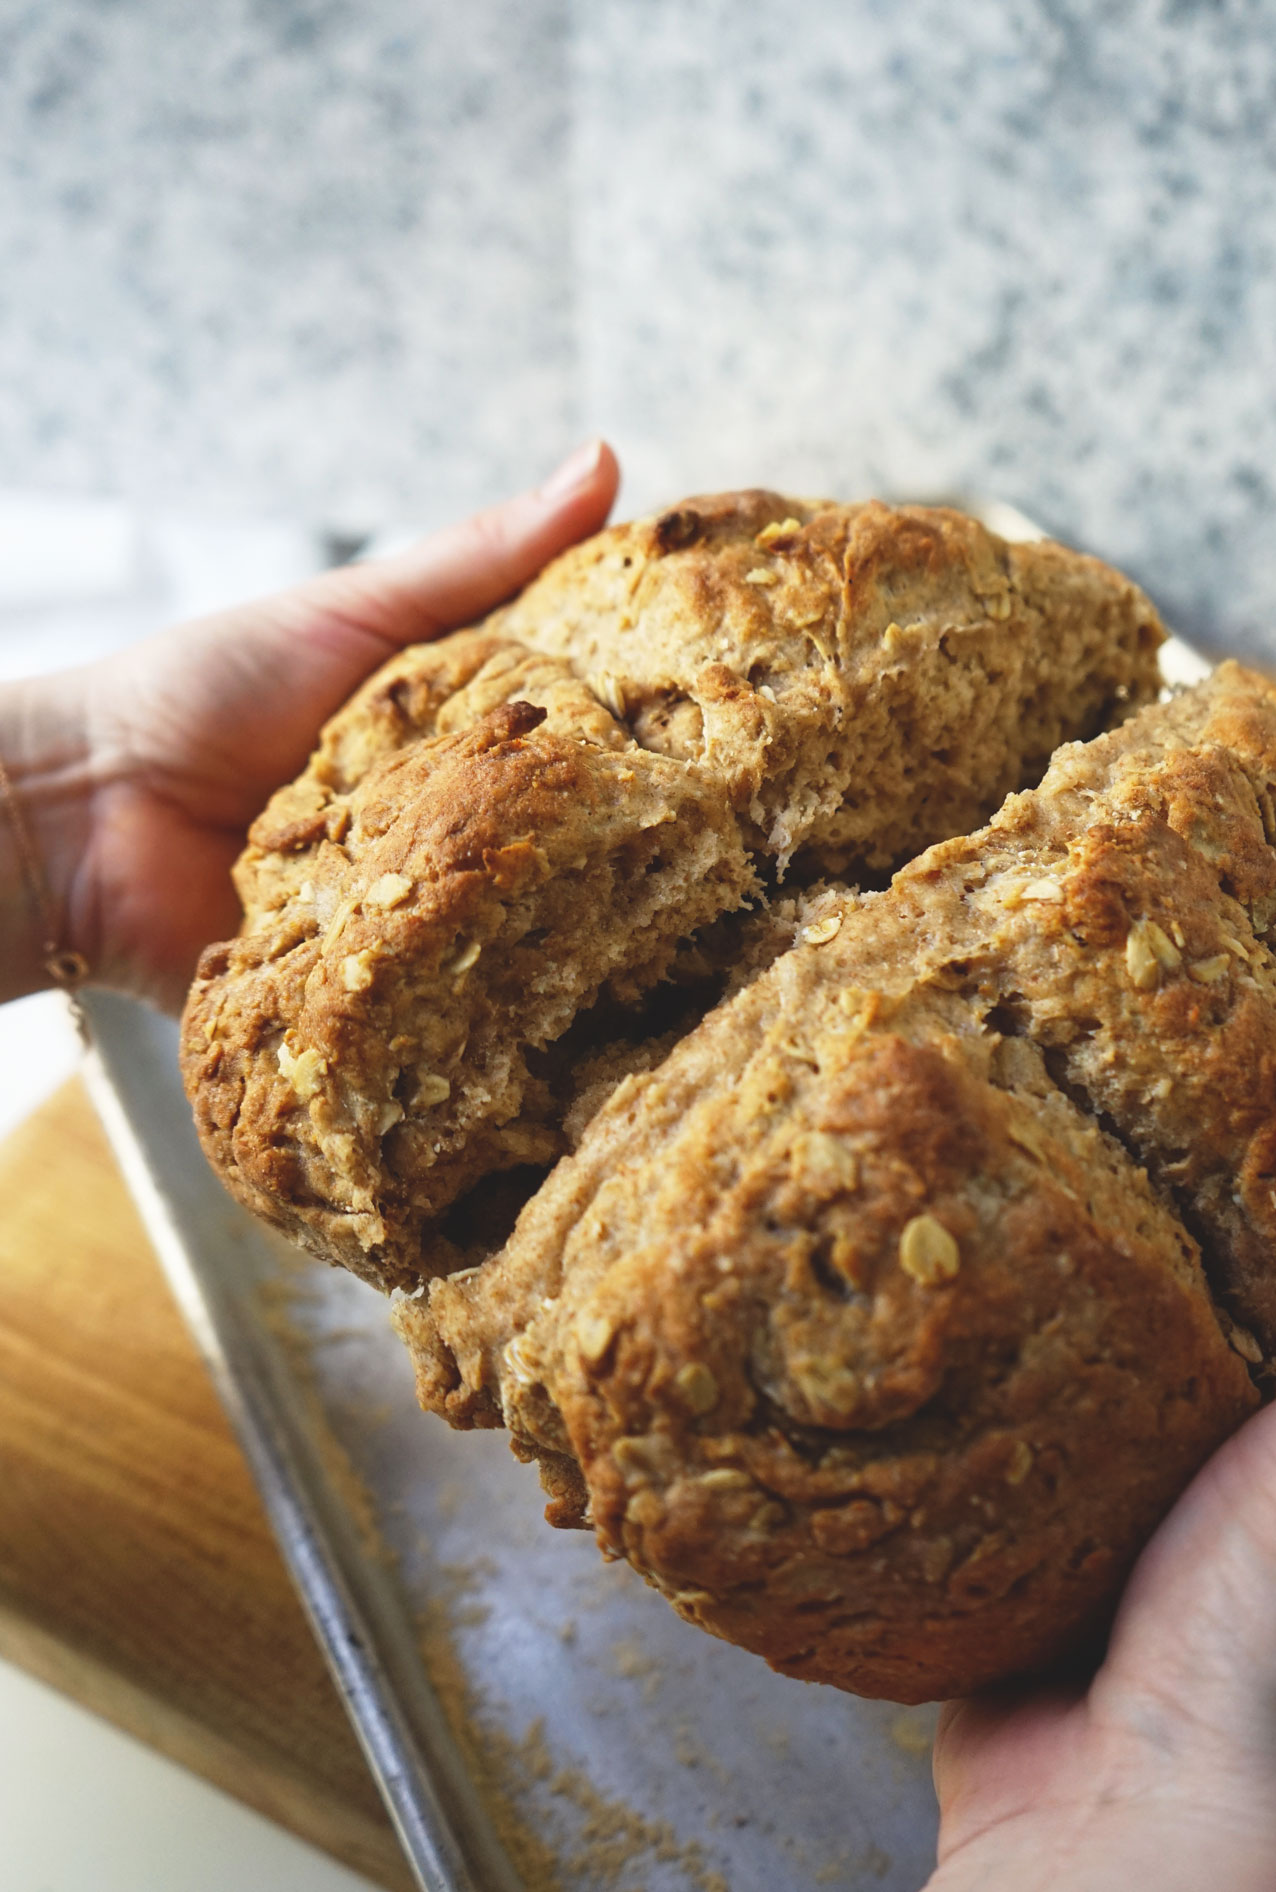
[[87, 993, 935, 1892]]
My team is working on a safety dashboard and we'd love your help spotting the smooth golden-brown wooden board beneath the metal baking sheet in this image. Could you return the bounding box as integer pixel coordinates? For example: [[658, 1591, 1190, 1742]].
[[0, 1080, 413, 1892]]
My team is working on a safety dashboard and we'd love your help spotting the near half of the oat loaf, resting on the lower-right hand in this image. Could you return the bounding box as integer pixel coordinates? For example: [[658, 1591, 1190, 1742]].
[[399, 666, 1276, 1699]]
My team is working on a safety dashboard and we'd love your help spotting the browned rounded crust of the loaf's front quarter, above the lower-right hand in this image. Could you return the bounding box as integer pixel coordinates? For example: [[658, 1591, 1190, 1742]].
[[399, 1033, 1255, 1699]]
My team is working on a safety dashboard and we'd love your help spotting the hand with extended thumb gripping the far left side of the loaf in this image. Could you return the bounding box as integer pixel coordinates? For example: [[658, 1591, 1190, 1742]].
[[0, 443, 619, 1007]]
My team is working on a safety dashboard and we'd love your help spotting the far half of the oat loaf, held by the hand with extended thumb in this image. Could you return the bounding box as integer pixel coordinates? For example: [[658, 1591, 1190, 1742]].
[[184, 492, 1162, 1287]]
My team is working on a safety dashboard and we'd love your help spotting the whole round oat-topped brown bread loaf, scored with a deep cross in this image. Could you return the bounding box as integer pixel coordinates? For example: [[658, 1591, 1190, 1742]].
[[174, 494, 1276, 1699]]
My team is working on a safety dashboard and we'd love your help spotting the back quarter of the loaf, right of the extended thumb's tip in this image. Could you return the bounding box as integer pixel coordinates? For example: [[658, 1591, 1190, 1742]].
[[492, 492, 1162, 874]]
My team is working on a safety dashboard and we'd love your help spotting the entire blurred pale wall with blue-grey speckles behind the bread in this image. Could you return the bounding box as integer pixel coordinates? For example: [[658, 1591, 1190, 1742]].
[[0, 0, 1276, 653]]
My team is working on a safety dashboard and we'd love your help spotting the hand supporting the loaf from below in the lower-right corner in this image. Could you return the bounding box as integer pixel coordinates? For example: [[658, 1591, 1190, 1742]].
[[926, 1406, 1276, 1892]]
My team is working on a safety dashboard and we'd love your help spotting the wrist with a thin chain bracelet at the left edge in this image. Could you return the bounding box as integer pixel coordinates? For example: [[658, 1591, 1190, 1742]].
[[0, 672, 93, 999]]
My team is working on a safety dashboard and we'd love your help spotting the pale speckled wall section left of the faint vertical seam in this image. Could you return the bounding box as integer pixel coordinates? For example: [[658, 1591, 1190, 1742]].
[[0, 0, 576, 524]]
